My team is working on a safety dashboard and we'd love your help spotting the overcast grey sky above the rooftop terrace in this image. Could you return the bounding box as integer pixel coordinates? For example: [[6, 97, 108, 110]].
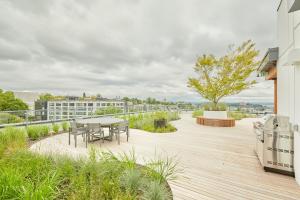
[[0, 0, 279, 101]]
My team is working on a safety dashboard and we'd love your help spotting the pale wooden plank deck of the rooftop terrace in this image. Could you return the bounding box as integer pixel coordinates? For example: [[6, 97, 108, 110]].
[[31, 113, 300, 200]]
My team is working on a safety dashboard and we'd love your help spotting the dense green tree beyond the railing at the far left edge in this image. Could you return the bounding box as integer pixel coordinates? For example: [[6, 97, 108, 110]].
[[0, 89, 28, 111]]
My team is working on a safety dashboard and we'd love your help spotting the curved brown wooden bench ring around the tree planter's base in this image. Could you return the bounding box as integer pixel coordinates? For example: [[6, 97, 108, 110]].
[[197, 117, 235, 127]]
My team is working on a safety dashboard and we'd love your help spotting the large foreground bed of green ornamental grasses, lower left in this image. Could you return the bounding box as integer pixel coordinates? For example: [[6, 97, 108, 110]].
[[0, 127, 177, 200]]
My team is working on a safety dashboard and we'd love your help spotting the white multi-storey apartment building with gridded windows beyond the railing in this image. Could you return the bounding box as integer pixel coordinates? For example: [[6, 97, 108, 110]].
[[47, 100, 125, 120]]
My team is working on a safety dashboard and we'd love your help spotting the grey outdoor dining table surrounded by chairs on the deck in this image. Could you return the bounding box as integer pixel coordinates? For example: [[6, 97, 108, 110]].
[[76, 117, 125, 140]]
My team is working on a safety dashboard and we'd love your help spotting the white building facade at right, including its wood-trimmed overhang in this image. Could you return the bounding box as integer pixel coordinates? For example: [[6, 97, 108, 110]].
[[260, 0, 300, 184]]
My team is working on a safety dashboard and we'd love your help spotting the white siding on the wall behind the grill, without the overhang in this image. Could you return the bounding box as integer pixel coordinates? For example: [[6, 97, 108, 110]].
[[277, 0, 300, 184]]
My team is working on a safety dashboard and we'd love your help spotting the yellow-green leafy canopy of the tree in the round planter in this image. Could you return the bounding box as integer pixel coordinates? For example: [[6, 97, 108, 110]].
[[188, 40, 259, 107]]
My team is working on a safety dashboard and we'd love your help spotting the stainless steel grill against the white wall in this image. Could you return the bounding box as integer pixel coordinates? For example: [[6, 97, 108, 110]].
[[254, 115, 294, 174]]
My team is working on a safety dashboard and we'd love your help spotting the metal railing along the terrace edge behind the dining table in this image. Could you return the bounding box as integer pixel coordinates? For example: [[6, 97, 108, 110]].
[[0, 105, 185, 128]]
